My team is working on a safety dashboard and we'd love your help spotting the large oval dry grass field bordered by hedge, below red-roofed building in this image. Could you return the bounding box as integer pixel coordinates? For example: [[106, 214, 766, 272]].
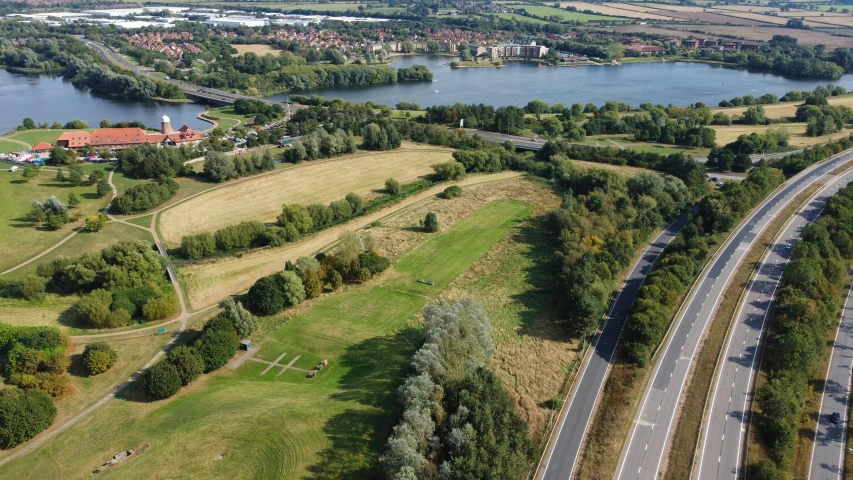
[[160, 144, 452, 246]]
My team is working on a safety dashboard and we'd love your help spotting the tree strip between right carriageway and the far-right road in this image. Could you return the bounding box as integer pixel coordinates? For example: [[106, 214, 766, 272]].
[[749, 184, 853, 479]]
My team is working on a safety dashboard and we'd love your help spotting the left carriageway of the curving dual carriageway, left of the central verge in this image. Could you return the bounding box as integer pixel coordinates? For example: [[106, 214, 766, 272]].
[[615, 150, 853, 479]]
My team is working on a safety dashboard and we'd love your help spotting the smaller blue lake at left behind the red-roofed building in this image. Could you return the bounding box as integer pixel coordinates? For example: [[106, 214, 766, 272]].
[[0, 70, 211, 133]]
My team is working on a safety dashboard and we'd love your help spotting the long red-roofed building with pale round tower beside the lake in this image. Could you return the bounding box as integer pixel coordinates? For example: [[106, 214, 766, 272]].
[[56, 115, 203, 149]]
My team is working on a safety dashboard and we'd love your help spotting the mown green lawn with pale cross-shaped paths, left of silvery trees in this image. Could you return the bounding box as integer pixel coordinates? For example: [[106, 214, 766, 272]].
[[0, 200, 532, 479]]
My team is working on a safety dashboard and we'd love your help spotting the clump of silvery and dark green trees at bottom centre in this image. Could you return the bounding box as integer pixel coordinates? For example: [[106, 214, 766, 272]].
[[379, 299, 534, 479]]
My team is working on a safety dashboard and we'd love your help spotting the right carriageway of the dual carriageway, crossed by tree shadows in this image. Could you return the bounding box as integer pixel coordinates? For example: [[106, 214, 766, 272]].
[[696, 163, 853, 480]]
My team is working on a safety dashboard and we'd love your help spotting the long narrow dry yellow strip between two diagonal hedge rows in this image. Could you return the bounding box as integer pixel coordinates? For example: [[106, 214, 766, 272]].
[[178, 172, 520, 309]]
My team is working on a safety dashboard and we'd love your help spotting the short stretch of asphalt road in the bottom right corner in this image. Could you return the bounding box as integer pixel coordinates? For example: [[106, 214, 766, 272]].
[[809, 280, 853, 480]]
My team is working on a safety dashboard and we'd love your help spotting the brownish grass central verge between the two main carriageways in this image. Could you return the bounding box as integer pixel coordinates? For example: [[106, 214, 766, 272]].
[[664, 185, 821, 480]]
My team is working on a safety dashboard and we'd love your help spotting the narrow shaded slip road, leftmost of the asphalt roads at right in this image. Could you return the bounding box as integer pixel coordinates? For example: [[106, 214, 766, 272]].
[[536, 213, 687, 480]]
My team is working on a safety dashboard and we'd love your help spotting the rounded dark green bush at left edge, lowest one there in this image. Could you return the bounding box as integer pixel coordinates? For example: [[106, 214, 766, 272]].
[[0, 388, 56, 448]]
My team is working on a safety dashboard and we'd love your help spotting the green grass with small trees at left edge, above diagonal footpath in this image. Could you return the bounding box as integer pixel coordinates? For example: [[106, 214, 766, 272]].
[[0, 171, 109, 272]]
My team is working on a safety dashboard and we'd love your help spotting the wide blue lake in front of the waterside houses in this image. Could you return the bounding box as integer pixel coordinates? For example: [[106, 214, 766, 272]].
[[273, 55, 853, 107]]
